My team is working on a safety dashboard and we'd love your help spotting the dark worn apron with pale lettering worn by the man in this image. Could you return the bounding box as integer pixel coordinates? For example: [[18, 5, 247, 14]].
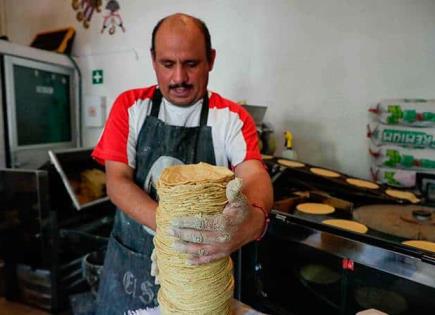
[[97, 89, 216, 315]]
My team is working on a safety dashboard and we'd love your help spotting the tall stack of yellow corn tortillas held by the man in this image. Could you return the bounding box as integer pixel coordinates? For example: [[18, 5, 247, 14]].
[[154, 163, 234, 315]]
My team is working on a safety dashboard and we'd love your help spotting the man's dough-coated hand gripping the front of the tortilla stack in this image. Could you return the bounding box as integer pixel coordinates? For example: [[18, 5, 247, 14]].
[[169, 178, 265, 265]]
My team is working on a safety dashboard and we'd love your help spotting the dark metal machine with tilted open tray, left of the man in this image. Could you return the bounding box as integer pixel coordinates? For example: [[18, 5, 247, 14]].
[[0, 149, 114, 312]]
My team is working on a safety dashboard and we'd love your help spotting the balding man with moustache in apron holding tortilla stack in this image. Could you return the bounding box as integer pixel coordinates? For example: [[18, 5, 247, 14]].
[[93, 14, 273, 315]]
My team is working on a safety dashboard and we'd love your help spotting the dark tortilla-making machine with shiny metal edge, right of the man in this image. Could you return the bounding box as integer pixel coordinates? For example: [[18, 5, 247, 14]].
[[241, 161, 435, 315]]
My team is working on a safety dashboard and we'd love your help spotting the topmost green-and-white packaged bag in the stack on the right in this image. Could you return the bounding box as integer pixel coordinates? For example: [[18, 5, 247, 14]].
[[369, 99, 435, 127]]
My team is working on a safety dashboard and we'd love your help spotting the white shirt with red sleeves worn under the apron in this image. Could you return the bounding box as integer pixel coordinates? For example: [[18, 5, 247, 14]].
[[92, 86, 261, 168]]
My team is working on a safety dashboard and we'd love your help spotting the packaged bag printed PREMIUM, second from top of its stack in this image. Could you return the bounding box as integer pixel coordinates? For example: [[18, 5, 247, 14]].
[[367, 123, 435, 149]]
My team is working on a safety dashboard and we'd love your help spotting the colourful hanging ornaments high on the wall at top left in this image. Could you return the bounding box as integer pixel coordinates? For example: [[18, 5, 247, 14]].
[[71, 0, 125, 35]]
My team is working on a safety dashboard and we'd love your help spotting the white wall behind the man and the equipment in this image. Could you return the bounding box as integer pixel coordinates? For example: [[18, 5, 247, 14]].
[[4, 0, 435, 177]]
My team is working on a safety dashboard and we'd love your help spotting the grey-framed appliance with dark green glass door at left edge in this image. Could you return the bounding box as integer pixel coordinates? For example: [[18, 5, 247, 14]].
[[0, 40, 81, 169]]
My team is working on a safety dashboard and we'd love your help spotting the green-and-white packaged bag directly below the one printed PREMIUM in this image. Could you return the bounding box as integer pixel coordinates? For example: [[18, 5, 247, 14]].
[[369, 145, 435, 171]]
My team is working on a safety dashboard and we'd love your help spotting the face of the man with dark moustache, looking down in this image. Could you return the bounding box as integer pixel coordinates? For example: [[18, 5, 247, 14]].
[[153, 23, 215, 106]]
